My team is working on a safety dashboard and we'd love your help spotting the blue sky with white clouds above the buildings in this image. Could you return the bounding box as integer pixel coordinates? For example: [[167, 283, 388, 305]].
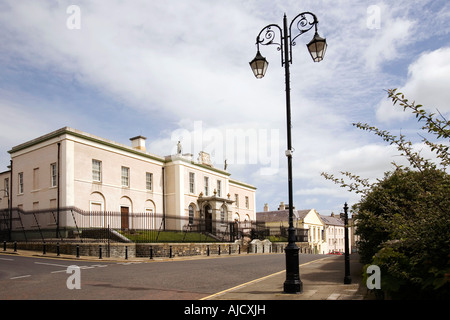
[[0, 0, 450, 215]]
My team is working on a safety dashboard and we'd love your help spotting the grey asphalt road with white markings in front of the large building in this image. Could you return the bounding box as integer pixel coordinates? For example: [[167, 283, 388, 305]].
[[0, 253, 323, 300]]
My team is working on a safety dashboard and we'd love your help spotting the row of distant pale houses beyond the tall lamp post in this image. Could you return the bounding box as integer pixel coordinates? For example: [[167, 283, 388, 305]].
[[256, 202, 356, 254]]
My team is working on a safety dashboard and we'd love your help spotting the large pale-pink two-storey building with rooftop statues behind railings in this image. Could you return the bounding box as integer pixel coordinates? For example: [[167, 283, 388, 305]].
[[0, 127, 256, 241]]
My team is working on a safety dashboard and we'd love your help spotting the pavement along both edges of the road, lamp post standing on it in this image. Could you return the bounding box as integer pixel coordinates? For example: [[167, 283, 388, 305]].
[[2, 250, 375, 300]]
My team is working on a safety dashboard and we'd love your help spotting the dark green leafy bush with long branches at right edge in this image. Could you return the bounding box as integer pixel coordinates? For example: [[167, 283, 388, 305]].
[[322, 89, 450, 299]]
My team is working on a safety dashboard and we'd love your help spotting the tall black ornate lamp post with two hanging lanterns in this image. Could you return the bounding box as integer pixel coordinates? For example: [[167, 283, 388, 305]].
[[250, 12, 327, 293]]
